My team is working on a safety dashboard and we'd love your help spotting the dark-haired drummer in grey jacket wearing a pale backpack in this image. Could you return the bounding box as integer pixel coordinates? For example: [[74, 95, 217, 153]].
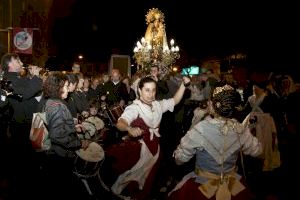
[[39, 72, 90, 199]]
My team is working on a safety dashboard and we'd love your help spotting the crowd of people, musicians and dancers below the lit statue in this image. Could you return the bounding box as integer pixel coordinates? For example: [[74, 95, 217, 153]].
[[0, 53, 299, 199]]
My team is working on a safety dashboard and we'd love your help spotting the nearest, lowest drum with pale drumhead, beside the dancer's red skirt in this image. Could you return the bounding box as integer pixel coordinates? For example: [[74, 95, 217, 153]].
[[74, 142, 104, 176]]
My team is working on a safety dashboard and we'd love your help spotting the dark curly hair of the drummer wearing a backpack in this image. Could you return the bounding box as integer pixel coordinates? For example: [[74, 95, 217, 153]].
[[43, 72, 68, 99]]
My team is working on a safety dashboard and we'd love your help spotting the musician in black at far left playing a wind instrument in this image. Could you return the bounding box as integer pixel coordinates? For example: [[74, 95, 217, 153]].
[[1, 53, 42, 198]]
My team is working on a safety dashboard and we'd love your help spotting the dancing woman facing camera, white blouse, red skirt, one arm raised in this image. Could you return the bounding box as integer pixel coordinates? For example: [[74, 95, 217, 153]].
[[106, 77, 190, 199]]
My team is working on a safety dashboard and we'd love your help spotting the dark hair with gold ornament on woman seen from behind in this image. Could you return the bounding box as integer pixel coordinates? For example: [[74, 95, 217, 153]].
[[211, 85, 241, 118]]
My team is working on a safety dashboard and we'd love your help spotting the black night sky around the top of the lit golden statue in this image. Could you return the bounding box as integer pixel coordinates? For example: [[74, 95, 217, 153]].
[[53, 0, 300, 71]]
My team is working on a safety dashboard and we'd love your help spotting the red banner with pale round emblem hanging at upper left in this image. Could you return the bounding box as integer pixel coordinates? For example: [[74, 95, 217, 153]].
[[13, 28, 33, 54]]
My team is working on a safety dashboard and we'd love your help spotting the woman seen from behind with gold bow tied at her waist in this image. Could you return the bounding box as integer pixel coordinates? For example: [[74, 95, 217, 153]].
[[169, 85, 262, 200]]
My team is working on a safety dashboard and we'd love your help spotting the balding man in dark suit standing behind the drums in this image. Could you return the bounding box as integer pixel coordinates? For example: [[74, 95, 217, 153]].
[[100, 69, 129, 107]]
